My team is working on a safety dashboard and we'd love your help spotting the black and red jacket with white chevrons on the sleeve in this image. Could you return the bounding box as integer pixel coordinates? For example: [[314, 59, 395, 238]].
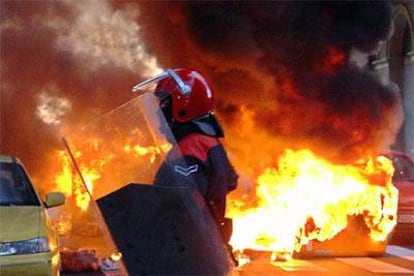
[[155, 117, 238, 223]]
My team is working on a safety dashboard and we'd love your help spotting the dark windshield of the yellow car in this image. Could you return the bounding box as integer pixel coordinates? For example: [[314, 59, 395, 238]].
[[0, 163, 40, 206]]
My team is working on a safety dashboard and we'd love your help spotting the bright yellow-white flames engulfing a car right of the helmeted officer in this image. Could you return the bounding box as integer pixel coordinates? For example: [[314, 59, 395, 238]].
[[228, 150, 398, 258]]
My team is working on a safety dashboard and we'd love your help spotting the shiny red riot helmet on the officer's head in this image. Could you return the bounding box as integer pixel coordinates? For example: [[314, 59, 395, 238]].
[[155, 68, 213, 122]]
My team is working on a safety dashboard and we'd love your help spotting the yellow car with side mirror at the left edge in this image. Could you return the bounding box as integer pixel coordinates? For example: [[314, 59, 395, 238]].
[[0, 154, 65, 276]]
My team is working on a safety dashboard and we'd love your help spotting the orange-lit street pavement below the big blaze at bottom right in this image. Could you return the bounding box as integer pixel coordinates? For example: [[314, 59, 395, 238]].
[[230, 245, 414, 276]]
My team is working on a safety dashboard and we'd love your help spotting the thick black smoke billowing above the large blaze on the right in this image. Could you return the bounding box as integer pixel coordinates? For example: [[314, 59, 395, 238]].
[[135, 1, 401, 163]]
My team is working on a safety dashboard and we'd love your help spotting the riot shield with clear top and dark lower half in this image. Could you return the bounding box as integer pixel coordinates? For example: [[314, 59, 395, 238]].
[[59, 89, 231, 274]]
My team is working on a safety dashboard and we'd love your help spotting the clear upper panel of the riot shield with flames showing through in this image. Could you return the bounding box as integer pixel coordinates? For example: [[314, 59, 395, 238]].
[[65, 93, 175, 200]]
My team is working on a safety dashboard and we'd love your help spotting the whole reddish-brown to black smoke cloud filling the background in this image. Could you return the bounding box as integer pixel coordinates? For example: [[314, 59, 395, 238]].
[[0, 1, 402, 187]]
